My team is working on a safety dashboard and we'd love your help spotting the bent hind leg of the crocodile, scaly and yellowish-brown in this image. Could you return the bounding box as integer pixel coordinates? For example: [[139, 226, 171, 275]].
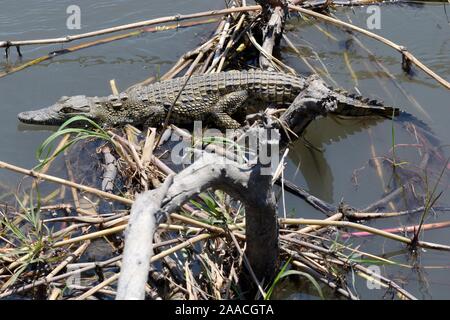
[[209, 90, 248, 129]]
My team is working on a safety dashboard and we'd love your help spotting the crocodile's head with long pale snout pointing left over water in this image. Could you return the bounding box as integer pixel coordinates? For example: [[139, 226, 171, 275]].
[[18, 96, 97, 125]]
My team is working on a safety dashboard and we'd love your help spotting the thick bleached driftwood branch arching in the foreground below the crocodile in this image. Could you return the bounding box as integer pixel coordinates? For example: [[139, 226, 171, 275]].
[[118, 143, 279, 299]]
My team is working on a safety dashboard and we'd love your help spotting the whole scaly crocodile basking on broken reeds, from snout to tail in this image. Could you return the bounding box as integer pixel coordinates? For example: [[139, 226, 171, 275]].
[[18, 70, 399, 129]]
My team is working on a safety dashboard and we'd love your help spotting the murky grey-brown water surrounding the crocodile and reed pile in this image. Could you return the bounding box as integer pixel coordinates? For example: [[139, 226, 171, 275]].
[[0, 0, 450, 299]]
